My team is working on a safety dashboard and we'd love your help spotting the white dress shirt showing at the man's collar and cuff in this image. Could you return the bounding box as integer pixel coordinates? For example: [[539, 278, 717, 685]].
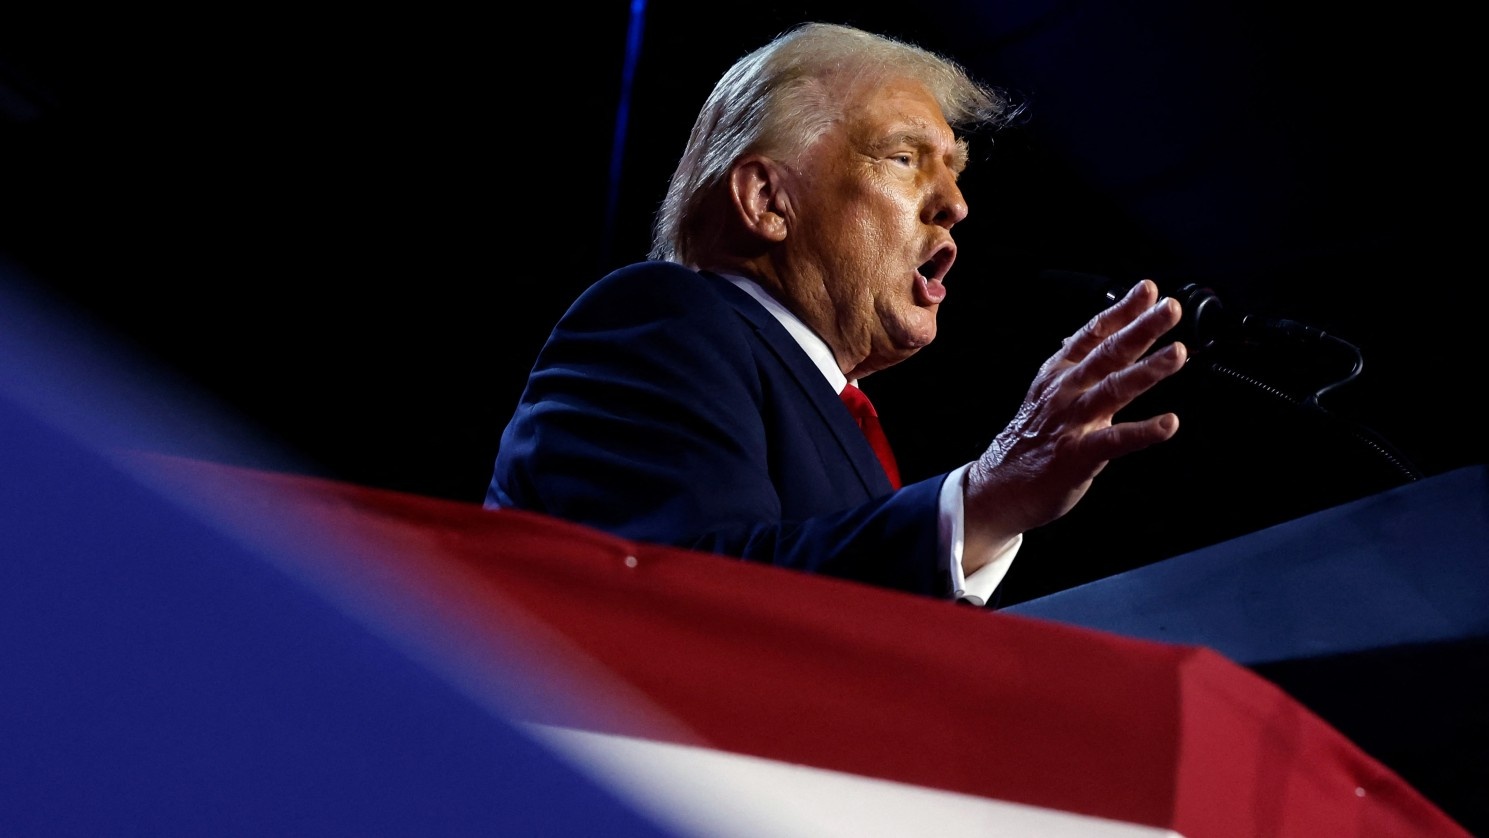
[[721, 274, 1023, 606]]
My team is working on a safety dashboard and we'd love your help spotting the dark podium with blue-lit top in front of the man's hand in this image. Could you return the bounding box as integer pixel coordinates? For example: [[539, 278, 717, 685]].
[[1004, 466, 1489, 834]]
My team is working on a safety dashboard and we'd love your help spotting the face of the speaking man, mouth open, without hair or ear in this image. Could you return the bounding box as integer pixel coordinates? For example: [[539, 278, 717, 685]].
[[783, 80, 966, 378]]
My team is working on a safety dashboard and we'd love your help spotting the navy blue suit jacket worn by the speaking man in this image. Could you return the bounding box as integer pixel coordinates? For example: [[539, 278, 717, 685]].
[[485, 262, 950, 595]]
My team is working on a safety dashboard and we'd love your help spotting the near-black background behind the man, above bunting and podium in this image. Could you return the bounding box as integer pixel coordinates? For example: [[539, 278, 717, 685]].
[[0, 0, 1489, 601]]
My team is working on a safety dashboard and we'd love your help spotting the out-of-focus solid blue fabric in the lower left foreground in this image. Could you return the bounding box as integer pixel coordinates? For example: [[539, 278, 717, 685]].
[[0, 315, 670, 838]]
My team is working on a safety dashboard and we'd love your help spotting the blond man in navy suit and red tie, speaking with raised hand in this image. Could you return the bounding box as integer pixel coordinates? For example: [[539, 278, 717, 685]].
[[485, 24, 1187, 604]]
